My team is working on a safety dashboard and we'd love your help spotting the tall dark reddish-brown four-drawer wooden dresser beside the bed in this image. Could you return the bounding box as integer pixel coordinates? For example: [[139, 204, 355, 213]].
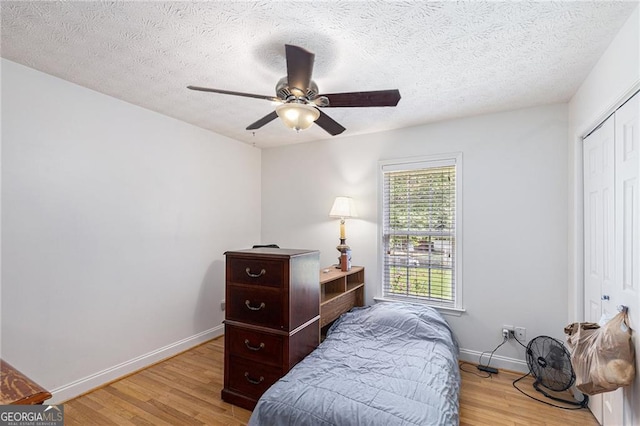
[[222, 248, 320, 410]]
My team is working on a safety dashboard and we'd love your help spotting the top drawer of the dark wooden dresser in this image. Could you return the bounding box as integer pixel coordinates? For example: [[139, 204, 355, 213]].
[[227, 257, 288, 287]]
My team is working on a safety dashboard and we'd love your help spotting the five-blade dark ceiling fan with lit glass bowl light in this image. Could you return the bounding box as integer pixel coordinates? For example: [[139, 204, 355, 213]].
[[187, 44, 400, 136]]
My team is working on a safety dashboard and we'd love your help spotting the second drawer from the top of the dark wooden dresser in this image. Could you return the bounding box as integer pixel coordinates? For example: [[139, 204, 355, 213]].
[[226, 285, 289, 330]]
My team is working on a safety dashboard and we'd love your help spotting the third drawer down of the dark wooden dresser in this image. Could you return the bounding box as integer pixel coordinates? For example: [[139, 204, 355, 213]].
[[225, 325, 284, 368]]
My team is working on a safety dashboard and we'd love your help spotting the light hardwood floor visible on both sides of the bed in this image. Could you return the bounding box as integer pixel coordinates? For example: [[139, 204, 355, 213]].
[[64, 337, 598, 426]]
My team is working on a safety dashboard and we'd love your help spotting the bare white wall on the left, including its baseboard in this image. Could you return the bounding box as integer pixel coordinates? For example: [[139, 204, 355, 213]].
[[1, 60, 261, 403]]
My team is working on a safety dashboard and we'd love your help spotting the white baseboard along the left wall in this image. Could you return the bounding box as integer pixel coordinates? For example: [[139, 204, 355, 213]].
[[45, 324, 224, 405]]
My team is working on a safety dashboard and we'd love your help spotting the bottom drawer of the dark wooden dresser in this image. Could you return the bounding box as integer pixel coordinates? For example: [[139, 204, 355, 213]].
[[228, 356, 283, 400]]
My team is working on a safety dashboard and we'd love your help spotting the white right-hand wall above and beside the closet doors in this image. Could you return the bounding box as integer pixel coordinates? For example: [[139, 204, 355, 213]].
[[568, 6, 640, 322]]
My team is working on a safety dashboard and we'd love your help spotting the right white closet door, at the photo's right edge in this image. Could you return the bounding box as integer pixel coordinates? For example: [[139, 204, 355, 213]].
[[604, 94, 640, 426]]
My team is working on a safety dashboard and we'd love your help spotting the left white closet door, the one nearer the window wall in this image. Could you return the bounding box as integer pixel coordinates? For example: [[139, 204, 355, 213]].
[[583, 117, 615, 424]]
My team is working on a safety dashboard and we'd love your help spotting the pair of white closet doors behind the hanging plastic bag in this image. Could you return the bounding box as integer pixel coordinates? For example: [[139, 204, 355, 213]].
[[583, 90, 640, 426]]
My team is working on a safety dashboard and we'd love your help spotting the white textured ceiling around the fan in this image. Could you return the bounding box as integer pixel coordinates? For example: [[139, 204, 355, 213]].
[[0, 1, 638, 147]]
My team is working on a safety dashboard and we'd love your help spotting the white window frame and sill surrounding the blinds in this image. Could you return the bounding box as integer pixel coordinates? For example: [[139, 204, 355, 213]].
[[374, 152, 464, 315]]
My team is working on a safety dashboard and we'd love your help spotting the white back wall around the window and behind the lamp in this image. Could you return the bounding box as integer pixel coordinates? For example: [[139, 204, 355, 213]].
[[262, 104, 567, 370]]
